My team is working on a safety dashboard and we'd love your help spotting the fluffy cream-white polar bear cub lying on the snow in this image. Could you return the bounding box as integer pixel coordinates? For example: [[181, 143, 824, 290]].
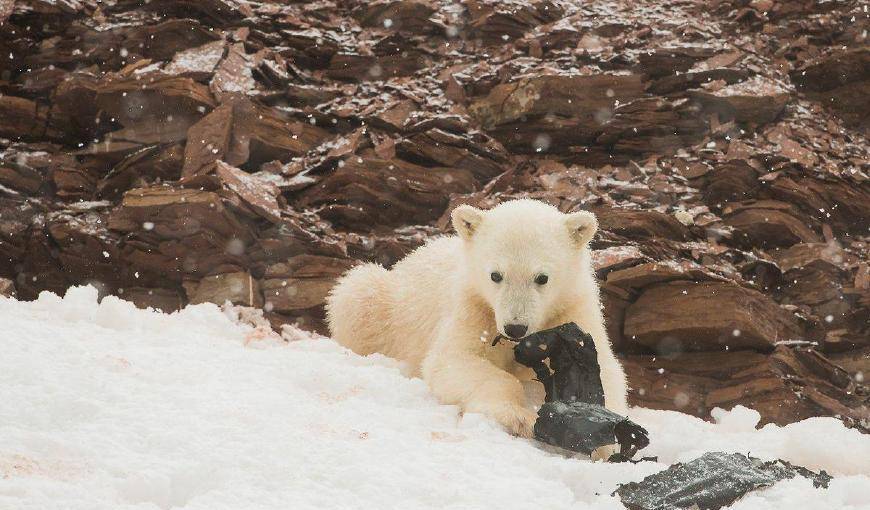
[[327, 200, 627, 437]]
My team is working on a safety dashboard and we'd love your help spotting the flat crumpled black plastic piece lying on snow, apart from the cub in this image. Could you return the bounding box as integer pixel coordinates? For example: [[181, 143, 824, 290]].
[[614, 452, 831, 510]]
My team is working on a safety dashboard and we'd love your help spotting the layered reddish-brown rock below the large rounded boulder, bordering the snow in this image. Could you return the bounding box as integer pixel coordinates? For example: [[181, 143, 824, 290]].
[[623, 346, 870, 431]]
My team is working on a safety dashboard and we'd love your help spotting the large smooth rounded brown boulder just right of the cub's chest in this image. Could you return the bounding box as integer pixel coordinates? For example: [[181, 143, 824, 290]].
[[625, 281, 806, 353]]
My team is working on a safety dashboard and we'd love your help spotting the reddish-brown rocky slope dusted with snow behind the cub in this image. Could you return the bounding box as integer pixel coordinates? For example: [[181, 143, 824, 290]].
[[0, 0, 870, 430]]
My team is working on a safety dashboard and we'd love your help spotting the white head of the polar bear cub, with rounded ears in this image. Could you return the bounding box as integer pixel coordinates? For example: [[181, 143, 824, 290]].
[[451, 200, 598, 338]]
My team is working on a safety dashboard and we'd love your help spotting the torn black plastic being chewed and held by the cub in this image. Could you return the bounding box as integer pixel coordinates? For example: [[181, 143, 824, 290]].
[[514, 322, 649, 461]]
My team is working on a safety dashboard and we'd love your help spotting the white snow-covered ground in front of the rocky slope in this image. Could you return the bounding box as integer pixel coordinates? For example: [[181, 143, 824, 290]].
[[0, 287, 870, 510]]
